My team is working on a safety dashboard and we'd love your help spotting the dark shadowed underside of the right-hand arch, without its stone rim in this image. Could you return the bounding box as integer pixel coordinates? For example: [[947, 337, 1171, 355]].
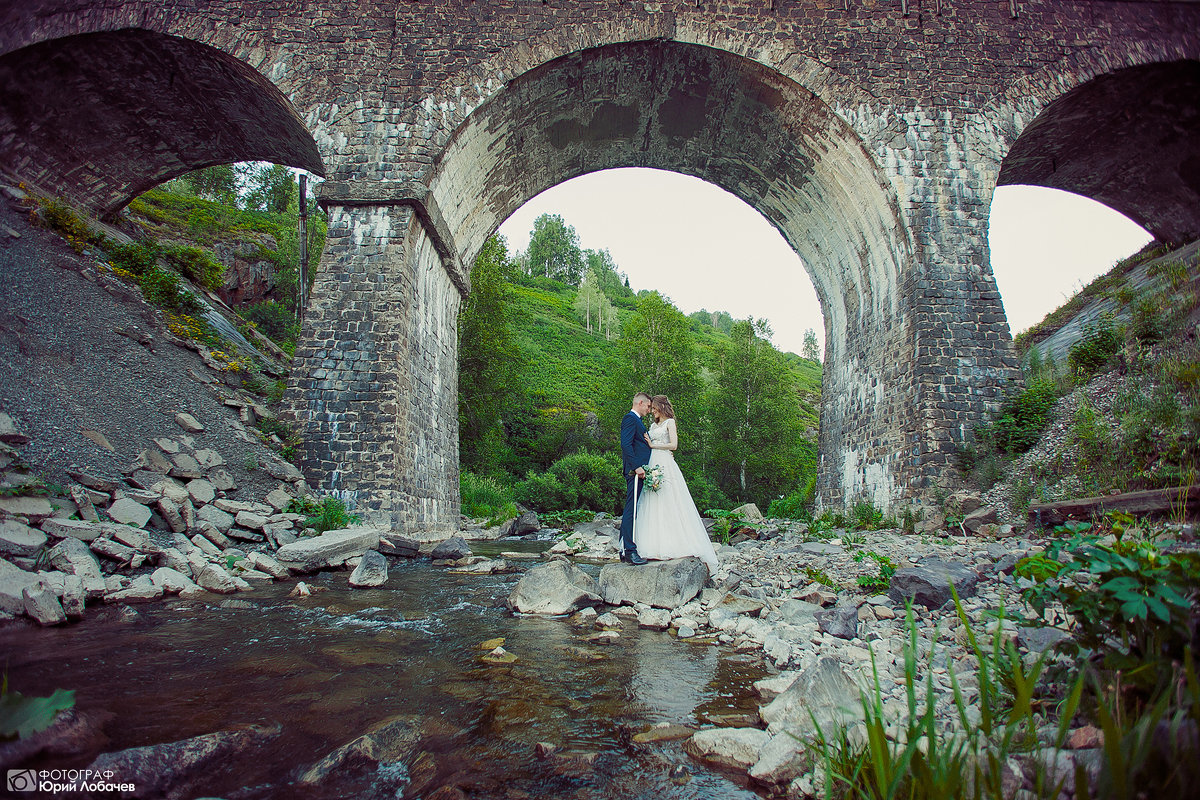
[[997, 59, 1200, 243]]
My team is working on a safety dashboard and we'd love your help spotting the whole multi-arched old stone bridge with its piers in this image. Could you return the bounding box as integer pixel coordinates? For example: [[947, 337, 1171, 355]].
[[0, 0, 1200, 530]]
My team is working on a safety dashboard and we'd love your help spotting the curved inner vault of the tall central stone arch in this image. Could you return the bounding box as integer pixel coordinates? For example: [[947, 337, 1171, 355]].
[[419, 40, 916, 507]]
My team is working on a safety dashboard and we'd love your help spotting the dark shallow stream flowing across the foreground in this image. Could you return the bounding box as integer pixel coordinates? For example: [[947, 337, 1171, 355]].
[[0, 542, 764, 800]]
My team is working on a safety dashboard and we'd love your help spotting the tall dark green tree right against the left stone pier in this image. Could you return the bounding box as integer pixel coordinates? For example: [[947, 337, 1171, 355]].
[[458, 236, 520, 474]]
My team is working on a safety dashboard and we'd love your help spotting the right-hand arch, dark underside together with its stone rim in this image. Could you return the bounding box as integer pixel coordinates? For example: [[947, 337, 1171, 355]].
[[980, 42, 1200, 242]]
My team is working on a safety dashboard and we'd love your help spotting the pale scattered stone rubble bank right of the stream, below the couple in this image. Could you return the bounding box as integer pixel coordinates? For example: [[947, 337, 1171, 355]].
[[492, 506, 1118, 798]]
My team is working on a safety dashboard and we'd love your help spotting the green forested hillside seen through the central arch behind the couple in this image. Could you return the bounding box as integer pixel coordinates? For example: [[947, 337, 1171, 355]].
[[460, 215, 821, 513]]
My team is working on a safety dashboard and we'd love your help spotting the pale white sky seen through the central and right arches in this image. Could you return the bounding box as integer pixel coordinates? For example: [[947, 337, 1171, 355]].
[[499, 169, 1151, 353]]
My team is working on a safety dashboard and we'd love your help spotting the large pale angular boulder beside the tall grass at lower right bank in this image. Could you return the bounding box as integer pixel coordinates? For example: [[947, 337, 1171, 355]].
[[758, 656, 863, 739]]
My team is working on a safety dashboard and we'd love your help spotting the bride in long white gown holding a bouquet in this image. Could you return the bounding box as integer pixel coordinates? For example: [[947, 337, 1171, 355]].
[[634, 395, 716, 575]]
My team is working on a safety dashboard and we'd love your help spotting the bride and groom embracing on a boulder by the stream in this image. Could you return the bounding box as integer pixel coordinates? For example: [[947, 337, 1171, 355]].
[[620, 392, 716, 575]]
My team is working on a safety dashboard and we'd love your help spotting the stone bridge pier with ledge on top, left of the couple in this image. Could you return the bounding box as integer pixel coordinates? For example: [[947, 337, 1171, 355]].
[[284, 192, 462, 534]]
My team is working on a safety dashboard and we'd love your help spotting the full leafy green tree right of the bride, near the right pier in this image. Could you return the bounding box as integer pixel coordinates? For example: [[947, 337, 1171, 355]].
[[709, 319, 815, 507]]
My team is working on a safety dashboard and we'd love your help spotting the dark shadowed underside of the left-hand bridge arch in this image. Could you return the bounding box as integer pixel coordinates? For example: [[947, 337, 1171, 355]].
[[0, 28, 324, 213]]
